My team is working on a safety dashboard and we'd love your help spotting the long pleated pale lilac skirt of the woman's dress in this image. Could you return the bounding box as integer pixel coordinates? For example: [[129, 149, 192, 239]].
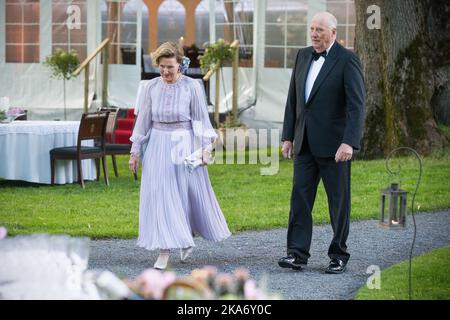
[[137, 128, 231, 250]]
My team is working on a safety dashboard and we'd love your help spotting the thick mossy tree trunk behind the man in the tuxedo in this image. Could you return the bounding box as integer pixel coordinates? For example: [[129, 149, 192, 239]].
[[355, 0, 450, 158]]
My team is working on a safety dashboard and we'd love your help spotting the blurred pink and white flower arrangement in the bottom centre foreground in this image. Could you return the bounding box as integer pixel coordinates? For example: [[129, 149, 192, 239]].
[[125, 266, 281, 300]]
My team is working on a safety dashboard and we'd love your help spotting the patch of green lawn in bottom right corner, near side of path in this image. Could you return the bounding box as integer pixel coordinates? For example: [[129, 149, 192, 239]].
[[356, 247, 450, 300]]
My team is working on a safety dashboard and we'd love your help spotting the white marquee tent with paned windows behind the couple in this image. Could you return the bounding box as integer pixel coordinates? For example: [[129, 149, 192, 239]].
[[0, 0, 355, 128]]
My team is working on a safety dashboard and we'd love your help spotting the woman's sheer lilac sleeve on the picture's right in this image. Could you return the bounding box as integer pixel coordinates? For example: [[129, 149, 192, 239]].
[[191, 80, 217, 151]]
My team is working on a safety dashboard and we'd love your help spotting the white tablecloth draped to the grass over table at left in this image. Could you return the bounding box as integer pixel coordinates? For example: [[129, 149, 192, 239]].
[[0, 121, 96, 184]]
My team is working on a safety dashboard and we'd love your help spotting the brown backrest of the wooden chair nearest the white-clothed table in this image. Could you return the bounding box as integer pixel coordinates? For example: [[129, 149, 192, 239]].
[[78, 111, 109, 146]]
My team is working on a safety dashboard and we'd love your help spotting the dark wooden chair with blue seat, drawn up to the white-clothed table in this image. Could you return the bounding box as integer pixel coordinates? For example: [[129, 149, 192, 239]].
[[50, 111, 109, 189]]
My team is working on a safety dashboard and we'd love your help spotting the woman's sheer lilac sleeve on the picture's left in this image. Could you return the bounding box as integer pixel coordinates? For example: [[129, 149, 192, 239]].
[[130, 80, 152, 156]]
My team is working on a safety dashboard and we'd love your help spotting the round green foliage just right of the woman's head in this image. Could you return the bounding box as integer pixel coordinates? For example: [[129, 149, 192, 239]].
[[199, 39, 235, 73]]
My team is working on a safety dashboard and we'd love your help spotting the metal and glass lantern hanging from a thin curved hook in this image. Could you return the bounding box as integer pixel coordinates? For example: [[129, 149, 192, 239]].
[[380, 183, 408, 227]]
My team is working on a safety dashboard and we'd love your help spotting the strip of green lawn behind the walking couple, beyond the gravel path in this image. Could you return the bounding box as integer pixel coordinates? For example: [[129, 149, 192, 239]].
[[0, 149, 450, 238]]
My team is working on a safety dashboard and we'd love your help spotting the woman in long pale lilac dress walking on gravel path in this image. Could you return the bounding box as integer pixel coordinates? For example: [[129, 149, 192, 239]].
[[129, 42, 231, 269]]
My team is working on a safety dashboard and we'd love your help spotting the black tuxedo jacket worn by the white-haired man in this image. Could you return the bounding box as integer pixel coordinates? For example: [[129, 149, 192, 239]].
[[281, 42, 365, 157]]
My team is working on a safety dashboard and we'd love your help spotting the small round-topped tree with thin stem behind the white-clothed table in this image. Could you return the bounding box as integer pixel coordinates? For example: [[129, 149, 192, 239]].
[[44, 48, 79, 120]]
